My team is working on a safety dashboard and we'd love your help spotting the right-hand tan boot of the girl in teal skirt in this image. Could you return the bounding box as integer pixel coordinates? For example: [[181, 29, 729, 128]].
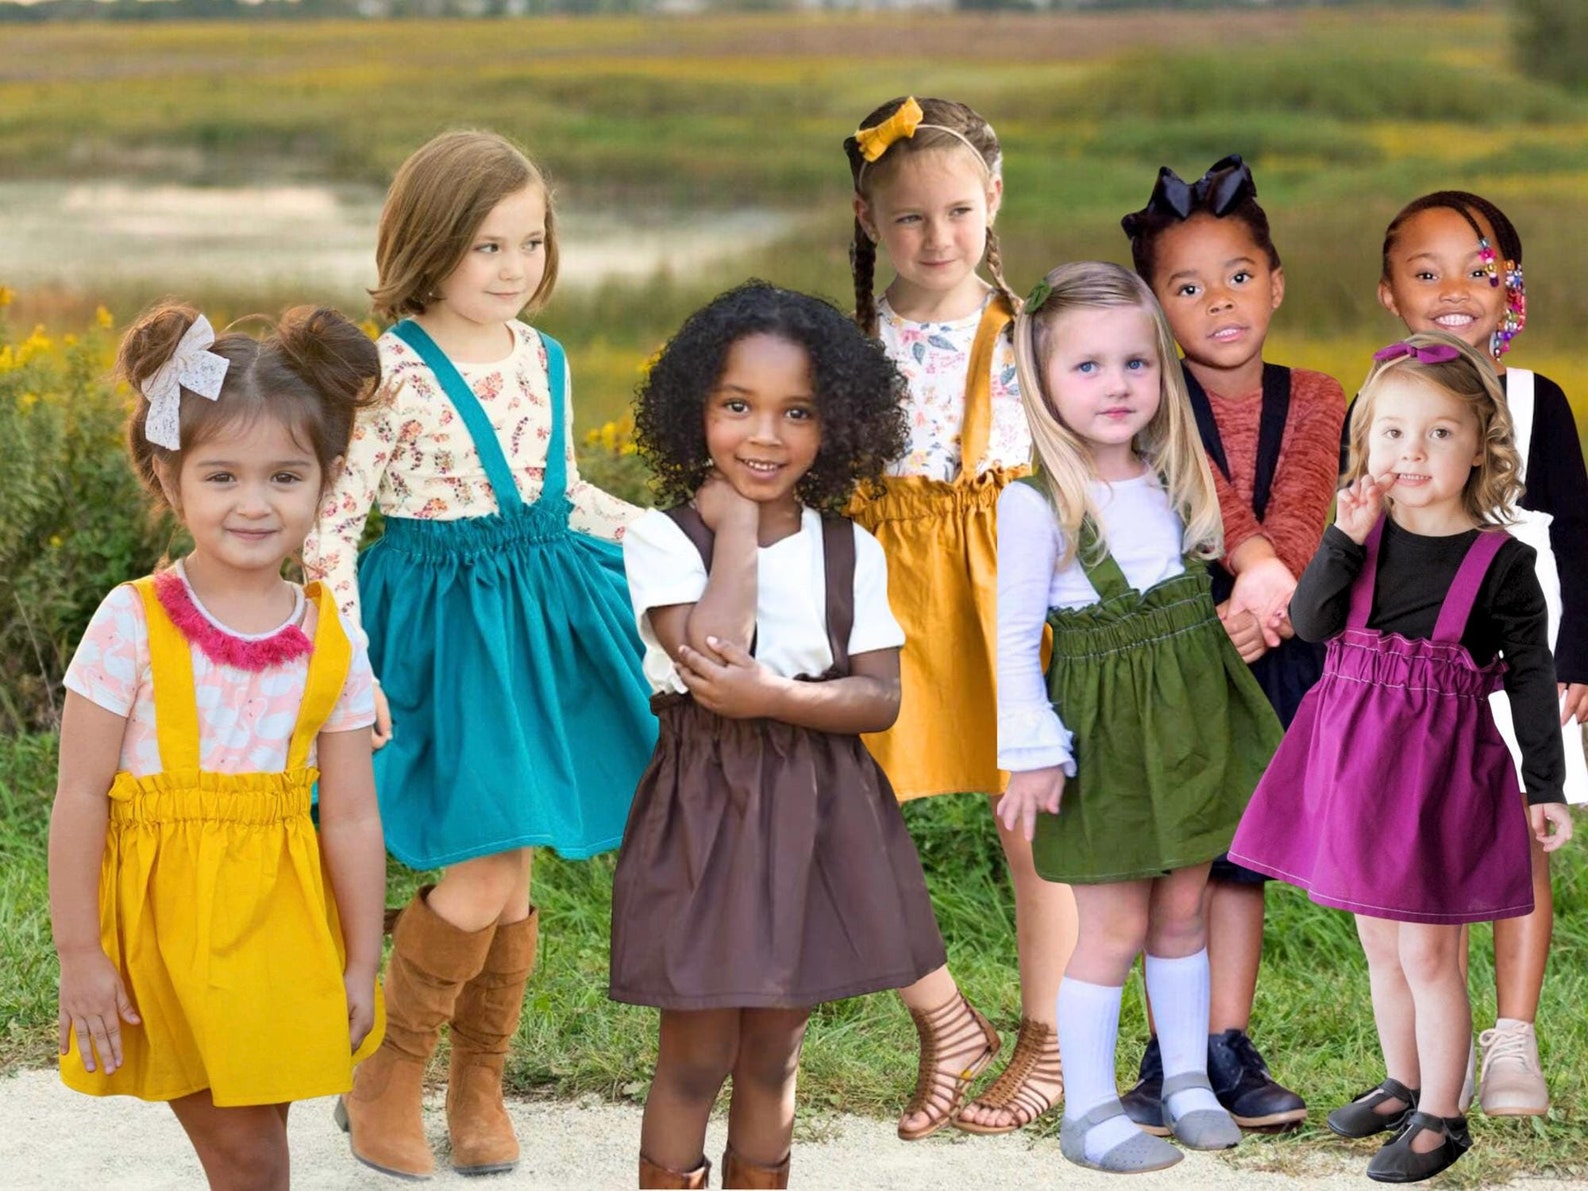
[[446, 907, 540, 1175]]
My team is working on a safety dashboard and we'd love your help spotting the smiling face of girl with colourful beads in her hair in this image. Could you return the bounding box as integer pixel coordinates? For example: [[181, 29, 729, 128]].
[[1378, 206, 1505, 356]]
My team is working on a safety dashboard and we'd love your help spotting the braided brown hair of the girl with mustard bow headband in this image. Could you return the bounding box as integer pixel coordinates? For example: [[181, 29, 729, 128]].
[[843, 95, 1019, 338]]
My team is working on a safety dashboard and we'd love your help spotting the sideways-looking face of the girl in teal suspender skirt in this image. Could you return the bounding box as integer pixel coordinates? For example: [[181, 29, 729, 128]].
[[427, 186, 546, 336]]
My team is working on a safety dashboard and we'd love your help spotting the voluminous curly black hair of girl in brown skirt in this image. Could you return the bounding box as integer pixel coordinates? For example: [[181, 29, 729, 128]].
[[634, 281, 908, 513]]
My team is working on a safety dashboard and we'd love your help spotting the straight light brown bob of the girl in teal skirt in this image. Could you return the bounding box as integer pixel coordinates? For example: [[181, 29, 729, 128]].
[[370, 130, 557, 319]]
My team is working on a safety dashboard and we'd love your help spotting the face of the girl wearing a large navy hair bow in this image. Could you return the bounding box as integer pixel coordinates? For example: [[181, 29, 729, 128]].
[[1153, 213, 1285, 382]]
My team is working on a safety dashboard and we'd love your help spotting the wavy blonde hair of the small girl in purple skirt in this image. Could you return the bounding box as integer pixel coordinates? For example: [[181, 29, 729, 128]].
[[1345, 330, 1523, 526]]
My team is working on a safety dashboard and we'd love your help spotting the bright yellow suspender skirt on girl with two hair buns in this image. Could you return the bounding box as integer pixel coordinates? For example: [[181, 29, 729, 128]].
[[60, 578, 384, 1107]]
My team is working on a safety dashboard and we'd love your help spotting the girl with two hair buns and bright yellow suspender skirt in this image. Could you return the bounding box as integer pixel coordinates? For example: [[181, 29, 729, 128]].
[[49, 305, 386, 1189]]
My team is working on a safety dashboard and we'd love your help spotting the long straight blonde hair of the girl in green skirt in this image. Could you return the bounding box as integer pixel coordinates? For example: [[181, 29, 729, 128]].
[[1015, 260, 1224, 567]]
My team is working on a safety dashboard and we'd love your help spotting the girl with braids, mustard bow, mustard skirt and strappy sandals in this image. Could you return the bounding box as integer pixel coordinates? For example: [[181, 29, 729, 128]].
[[843, 98, 1075, 1140]]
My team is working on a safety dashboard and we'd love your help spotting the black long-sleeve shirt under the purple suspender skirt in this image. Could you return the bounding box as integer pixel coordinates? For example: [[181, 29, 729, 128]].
[[1289, 519, 1566, 804]]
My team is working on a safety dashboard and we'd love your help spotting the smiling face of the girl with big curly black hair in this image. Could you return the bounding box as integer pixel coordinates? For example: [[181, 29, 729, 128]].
[[705, 333, 821, 503]]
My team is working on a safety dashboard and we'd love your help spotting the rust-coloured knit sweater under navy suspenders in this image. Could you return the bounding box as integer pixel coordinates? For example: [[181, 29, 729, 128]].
[[1207, 368, 1345, 578]]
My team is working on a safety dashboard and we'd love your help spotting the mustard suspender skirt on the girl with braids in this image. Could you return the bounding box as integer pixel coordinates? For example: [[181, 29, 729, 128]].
[[850, 294, 1026, 802]]
